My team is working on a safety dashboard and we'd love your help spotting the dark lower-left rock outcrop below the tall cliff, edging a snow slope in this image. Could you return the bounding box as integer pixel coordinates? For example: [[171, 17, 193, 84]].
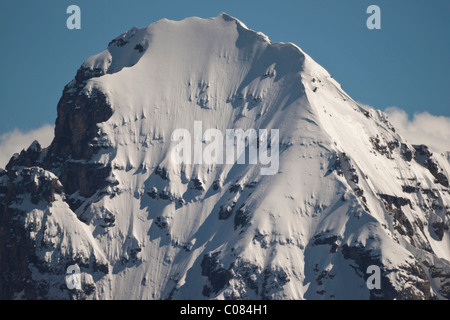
[[0, 167, 108, 299]]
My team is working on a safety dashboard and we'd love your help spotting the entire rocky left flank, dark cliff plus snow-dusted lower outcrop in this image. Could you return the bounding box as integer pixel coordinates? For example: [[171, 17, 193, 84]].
[[0, 60, 112, 299]]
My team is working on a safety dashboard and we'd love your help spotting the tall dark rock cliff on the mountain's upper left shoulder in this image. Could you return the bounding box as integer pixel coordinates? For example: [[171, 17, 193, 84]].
[[29, 63, 117, 210]]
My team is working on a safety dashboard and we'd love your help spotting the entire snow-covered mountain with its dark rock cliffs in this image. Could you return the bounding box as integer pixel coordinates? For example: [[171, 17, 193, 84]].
[[0, 14, 450, 299]]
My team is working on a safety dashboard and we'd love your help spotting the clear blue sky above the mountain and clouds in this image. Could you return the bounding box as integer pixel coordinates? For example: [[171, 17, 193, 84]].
[[0, 0, 450, 144]]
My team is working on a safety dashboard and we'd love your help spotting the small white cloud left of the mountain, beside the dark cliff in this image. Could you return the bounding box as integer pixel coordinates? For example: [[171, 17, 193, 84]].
[[0, 124, 54, 168]]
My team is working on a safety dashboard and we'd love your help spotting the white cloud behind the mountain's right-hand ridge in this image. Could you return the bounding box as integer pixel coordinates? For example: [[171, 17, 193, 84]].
[[384, 107, 450, 153]]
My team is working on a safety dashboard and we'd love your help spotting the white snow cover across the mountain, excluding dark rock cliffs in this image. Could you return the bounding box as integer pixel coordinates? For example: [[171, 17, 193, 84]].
[[7, 14, 450, 299]]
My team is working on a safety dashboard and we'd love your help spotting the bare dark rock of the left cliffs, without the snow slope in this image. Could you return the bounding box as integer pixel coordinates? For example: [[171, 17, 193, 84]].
[[0, 58, 133, 299]]
